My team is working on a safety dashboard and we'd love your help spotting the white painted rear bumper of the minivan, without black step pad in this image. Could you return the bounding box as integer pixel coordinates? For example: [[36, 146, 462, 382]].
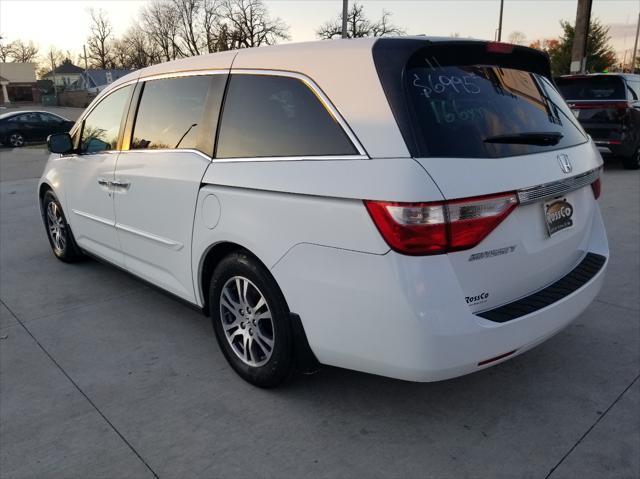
[[272, 205, 609, 381]]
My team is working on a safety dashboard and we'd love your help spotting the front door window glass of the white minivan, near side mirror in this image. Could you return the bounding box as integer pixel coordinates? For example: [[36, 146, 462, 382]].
[[80, 85, 133, 153]]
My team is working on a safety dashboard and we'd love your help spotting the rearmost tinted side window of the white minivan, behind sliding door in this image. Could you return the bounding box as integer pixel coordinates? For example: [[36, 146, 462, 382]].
[[216, 74, 357, 158]]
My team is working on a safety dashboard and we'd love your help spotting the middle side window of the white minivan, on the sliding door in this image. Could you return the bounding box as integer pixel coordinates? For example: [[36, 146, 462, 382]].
[[130, 76, 211, 150]]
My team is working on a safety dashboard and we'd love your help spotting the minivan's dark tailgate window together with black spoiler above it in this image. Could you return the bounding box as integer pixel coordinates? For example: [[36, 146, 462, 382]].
[[373, 39, 587, 158]]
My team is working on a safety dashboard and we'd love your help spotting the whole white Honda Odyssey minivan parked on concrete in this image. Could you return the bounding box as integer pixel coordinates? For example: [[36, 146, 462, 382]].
[[38, 37, 609, 387]]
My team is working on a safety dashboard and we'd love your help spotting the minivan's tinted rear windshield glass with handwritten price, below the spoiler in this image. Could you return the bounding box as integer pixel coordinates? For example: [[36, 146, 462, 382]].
[[405, 56, 586, 158]]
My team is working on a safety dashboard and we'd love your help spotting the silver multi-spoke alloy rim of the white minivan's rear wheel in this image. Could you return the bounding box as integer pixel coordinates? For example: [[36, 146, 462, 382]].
[[220, 276, 275, 367]]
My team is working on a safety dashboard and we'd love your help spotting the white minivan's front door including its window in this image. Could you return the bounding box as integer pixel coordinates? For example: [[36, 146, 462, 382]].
[[65, 85, 133, 266]]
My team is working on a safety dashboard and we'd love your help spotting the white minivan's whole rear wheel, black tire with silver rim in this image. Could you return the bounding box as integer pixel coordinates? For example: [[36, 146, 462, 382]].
[[209, 252, 294, 388]]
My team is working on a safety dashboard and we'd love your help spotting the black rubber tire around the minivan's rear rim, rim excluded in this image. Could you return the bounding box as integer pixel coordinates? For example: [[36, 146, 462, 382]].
[[209, 252, 293, 388]]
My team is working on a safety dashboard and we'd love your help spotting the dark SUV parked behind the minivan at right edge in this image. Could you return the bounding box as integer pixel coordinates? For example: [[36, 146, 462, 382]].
[[556, 73, 640, 170]]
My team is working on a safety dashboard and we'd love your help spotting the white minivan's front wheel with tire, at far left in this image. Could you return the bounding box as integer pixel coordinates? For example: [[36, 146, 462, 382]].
[[42, 190, 83, 263]]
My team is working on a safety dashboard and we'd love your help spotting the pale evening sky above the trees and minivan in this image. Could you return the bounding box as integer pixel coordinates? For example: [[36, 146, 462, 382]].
[[0, 0, 640, 65]]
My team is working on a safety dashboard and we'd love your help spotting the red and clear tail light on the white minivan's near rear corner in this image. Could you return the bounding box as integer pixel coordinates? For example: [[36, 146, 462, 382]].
[[364, 193, 518, 256]]
